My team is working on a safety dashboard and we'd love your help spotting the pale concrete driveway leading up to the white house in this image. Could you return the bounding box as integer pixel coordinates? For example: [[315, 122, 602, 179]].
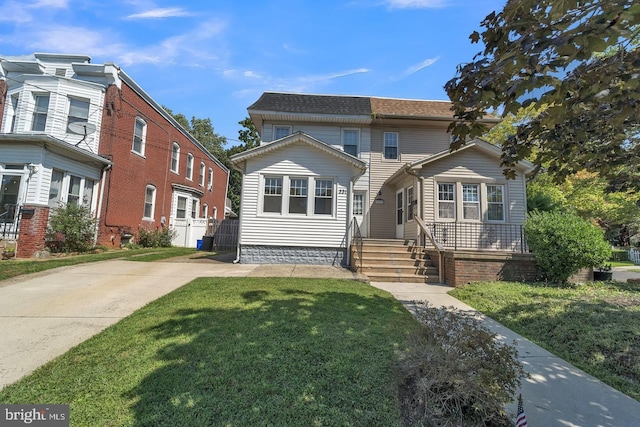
[[0, 259, 357, 389]]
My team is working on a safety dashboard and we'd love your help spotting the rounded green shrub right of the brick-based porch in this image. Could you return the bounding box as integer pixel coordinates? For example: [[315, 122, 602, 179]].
[[524, 212, 611, 283]]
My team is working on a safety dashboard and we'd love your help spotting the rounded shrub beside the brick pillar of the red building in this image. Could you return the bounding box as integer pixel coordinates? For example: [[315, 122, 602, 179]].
[[47, 203, 96, 252]]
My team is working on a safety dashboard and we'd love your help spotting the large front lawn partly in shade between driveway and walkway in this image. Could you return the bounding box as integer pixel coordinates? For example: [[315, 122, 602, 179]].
[[0, 278, 416, 426]]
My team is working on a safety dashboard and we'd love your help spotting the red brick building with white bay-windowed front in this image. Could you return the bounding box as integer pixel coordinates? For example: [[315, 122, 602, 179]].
[[0, 53, 229, 257]]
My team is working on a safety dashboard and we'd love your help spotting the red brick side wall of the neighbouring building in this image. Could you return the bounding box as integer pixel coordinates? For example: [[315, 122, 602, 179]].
[[98, 82, 227, 246]]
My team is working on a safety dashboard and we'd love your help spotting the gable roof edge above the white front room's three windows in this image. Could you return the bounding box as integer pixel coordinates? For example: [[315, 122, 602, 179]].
[[229, 132, 367, 173]]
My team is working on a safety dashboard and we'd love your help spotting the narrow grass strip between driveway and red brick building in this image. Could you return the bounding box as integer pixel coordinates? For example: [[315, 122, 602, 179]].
[[0, 247, 200, 280]]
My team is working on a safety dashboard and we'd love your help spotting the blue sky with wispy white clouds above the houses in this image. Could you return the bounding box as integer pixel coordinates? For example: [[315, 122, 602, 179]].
[[0, 0, 505, 144]]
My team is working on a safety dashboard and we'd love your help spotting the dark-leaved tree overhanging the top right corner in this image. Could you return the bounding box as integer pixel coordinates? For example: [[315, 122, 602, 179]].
[[445, 0, 640, 189]]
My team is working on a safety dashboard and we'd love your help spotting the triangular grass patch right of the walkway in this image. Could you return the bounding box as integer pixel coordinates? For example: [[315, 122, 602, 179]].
[[450, 282, 640, 400]]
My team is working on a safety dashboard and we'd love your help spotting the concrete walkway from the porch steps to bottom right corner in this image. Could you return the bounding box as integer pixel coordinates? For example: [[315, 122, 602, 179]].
[[371, 282, 640, 427]]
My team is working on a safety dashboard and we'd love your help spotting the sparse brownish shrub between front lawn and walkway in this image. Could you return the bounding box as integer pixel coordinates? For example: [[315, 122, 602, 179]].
[[398, 302, 525, 426]]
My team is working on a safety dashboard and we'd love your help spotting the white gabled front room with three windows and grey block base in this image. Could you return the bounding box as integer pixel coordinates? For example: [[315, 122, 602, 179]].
[[232, 132, 366, 265]]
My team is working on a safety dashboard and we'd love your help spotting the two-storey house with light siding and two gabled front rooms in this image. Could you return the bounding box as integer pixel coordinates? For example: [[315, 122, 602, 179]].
[[232, 92, 533, 263]]
